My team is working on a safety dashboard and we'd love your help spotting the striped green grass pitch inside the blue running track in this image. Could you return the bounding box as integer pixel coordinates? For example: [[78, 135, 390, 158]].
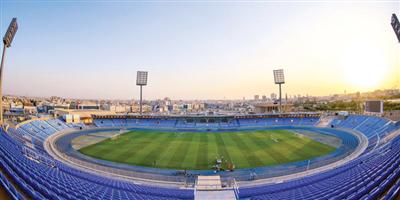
[[79, 130, 335, 169]]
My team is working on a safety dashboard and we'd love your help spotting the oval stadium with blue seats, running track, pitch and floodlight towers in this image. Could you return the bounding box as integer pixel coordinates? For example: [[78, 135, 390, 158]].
[[0, 2, 400, 200]]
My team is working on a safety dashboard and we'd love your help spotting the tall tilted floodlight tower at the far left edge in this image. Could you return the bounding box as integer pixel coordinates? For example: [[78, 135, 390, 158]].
[[0, 18, 18, 125]]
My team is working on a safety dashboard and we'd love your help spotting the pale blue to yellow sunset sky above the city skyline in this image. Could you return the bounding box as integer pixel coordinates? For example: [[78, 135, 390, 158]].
[[0, 0, 400, 99]]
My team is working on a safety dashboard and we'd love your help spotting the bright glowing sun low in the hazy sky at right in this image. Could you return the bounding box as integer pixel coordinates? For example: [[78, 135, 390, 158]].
[[340, 45, 388, 91]]
